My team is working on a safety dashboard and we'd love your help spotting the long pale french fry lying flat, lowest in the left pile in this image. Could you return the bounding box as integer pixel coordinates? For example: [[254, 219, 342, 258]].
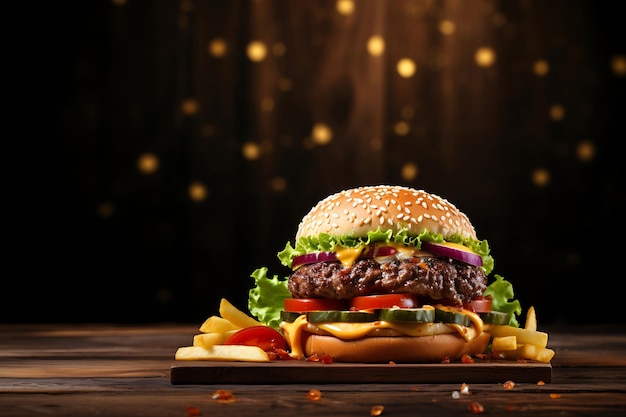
[[175, 345, 270, 362]]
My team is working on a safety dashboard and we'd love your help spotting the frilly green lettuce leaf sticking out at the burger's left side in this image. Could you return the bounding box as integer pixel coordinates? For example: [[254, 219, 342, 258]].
[[248, 267, 291, 329]]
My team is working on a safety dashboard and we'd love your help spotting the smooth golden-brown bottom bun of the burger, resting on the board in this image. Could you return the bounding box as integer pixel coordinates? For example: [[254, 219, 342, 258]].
[[304, 332, 490, 363]]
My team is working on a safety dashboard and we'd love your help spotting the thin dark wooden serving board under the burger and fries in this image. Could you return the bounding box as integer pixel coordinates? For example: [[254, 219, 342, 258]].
[[171, 360, 552, 384]]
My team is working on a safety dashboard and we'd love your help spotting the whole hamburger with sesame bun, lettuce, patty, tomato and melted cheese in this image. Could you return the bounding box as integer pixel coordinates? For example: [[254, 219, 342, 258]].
[[248, 185, 521, 363]]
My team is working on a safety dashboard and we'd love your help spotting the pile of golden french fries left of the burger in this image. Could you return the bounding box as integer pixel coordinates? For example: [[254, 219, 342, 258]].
[[175, 298, 270, 362]]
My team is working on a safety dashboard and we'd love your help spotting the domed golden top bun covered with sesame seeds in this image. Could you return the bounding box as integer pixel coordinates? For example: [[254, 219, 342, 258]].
[[296, 185, 477, 240]]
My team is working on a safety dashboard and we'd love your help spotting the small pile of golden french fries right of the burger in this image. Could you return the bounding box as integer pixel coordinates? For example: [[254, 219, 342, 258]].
[[491, 307, 554, 363]]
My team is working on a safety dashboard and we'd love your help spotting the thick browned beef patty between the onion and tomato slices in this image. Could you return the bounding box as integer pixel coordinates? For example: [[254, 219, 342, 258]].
[[288, 257, 487, 304]]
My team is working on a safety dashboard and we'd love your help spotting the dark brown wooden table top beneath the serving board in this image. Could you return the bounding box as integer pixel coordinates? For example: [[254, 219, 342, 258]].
[[0, 324, 626, 417]]
